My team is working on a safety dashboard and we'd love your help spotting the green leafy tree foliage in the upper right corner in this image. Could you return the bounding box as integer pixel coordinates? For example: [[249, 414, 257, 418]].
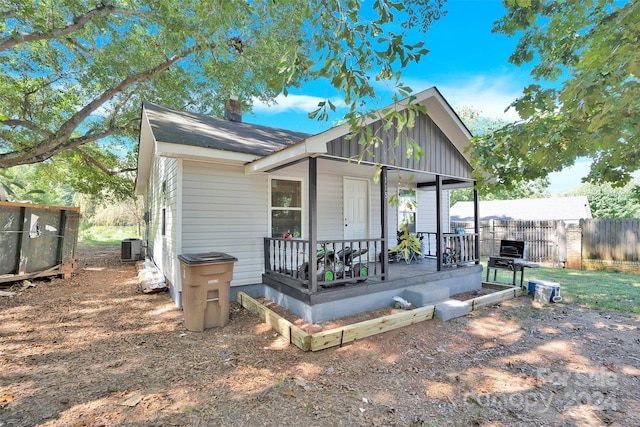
[[473, 0, 640, 191]]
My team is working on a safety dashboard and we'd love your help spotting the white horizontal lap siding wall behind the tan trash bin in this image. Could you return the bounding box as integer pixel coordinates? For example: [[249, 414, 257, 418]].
[[182, 160, 276, 286]]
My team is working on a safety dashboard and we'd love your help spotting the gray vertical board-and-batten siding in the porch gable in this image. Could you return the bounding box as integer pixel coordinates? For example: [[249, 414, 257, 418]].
[[327, 113, 473, 179]]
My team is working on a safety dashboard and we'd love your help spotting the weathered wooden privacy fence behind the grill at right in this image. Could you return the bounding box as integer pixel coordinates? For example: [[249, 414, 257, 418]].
[[451, 218, 640, 273]]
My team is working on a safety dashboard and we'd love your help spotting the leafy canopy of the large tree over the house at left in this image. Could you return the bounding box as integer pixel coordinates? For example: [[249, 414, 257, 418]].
[[0, 0, 443, 201]]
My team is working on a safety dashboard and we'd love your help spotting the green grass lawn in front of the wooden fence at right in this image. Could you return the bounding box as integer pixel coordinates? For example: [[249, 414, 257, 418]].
[[485, 264, 640, 315]]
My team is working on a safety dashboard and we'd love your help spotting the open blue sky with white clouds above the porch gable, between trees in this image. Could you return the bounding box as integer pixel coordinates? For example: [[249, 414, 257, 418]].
[[244, 0, 589, 194]]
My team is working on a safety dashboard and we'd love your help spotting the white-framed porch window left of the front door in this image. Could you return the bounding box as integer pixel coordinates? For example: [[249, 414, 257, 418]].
[[270, 178, 302, 237]]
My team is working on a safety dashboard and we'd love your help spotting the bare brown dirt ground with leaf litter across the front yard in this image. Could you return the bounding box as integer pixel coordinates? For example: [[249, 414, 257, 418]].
[[0, 247, 640, 427]]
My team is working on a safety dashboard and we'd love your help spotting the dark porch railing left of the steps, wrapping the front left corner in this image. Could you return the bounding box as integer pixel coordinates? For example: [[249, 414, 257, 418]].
[[264, 237, 384, 291]]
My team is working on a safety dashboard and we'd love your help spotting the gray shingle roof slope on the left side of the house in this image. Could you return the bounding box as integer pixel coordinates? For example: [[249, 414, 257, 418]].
[[144, 103, 309, 156]]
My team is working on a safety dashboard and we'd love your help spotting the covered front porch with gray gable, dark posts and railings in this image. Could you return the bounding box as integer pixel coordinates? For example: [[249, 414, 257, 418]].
[[245, 89, 482, 321]]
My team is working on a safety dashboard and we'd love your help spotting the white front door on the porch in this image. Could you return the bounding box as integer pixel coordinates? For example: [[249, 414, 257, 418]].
[[344, 178, 369, 239]]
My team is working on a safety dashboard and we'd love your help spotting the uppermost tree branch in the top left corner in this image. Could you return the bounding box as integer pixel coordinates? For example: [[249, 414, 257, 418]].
[[0, 4, 151, 52]]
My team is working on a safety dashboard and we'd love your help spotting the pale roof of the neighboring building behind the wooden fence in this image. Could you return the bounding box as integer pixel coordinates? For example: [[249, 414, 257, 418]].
[[450, 196, 592, 224]]
